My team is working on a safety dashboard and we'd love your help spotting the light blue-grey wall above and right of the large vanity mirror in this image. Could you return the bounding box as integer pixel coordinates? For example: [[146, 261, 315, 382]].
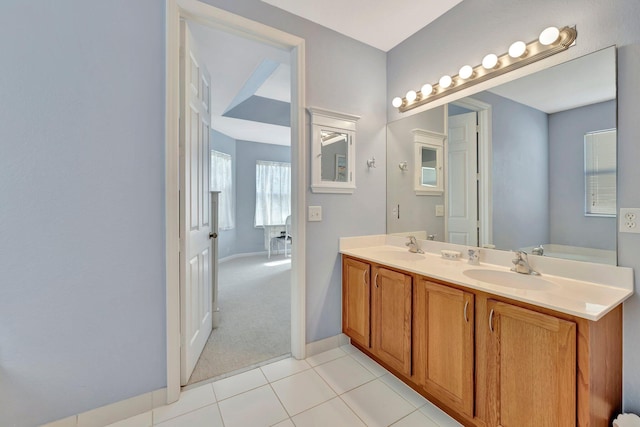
[[387, 0, 640, 412]]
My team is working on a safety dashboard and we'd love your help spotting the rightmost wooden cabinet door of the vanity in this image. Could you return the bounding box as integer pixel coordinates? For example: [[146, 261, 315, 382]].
[[487, 300, 576, 427]]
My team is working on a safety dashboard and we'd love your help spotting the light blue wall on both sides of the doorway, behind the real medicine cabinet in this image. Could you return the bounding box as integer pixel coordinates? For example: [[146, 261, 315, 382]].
[[0, 0, 386, 426]]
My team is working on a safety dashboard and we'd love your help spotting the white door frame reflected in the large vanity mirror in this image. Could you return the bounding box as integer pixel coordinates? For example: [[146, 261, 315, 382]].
[[445, 97, 493, 247]]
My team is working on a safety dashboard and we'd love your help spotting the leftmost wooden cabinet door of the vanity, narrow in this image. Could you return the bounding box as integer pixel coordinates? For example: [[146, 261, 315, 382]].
[[342, 257, 371, 347]]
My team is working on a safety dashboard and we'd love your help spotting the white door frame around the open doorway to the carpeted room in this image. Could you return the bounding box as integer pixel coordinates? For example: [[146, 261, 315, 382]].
[[165, 0, 307, 403]]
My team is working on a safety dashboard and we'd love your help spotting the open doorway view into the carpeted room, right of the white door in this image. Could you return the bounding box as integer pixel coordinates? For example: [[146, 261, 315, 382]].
[[182, 16, 293, 385]]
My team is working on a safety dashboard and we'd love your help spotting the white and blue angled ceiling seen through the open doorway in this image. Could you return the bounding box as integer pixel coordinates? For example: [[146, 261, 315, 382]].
[[189, 23, 291, 145]]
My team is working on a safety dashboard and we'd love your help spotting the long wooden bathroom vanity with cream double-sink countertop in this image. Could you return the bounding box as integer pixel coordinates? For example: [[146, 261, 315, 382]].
[[340, 236, 633, 427]]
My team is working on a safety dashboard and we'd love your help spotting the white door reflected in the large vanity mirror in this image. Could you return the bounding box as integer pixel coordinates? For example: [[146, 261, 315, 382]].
[[447, 112, 478, 246]]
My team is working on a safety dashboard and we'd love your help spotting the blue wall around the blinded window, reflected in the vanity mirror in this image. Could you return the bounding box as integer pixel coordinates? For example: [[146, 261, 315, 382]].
[[549, 101, 617, 250]]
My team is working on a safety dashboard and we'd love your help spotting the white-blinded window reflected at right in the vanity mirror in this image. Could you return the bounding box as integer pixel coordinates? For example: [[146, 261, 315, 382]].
[[584, 129, 617, 216]]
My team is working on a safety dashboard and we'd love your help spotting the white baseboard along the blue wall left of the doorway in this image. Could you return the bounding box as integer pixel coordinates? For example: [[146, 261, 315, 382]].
[[41, 388, 167, 427]]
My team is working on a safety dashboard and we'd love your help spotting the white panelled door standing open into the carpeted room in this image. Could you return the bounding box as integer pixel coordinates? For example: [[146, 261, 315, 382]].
[[180, 22, 213, 384]]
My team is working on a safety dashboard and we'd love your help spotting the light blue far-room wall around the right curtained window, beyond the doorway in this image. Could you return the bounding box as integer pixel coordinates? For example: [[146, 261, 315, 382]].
[[234, 141, 291, 254]]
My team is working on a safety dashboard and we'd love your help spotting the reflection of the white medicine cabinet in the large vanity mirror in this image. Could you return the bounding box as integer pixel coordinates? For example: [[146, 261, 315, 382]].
[[412, 129, 446, 196]]
